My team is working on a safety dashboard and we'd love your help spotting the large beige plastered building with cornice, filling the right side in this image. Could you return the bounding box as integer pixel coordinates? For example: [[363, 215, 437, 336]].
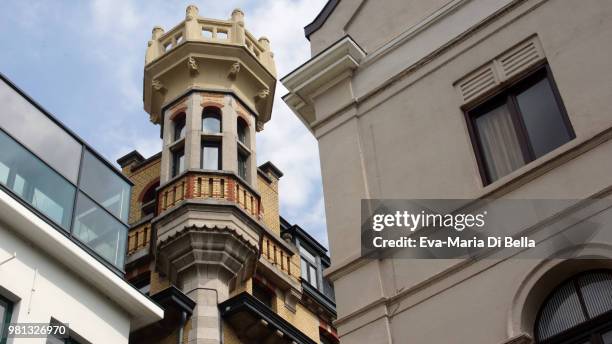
[[281, 0, 612, 344]]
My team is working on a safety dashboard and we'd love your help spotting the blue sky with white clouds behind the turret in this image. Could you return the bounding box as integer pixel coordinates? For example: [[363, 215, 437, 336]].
[[0, 0, 327, 247]]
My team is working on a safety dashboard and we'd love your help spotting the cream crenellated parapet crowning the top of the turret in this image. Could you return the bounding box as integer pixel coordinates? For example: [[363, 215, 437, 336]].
[[145, 5, 275, 74]]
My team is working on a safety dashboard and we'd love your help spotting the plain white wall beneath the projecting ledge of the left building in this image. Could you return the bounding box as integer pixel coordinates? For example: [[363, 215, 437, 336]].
[[0, 220, 130, 344]]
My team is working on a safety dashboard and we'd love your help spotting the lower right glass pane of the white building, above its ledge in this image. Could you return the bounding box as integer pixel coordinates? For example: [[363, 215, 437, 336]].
[[72, 193, 127, 268]]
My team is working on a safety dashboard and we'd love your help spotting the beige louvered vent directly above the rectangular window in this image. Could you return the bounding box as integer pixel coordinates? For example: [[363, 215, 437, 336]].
[[455, 36, 544, 103]]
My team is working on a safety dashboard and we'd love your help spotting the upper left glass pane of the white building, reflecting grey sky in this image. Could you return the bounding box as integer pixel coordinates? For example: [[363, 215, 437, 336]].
[[0, 80, 81, 184]]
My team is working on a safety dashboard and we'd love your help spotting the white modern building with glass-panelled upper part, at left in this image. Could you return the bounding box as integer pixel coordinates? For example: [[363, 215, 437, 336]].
[[0, 75, 164, 344]]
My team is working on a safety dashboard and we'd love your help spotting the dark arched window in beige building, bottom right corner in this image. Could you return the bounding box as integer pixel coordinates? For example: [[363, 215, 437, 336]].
[[534, 270, 612, 344]]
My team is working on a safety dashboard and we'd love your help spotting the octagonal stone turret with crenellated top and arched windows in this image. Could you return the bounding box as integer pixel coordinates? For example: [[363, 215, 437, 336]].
[[144, 5, 276, 343]]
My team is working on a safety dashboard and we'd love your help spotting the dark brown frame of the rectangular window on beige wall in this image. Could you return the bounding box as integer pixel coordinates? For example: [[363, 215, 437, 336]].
[[462, 61, 576, 186]]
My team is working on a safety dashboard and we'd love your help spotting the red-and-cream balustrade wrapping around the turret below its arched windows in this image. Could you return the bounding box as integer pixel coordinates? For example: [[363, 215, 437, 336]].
[[157, 171, 261, 220]]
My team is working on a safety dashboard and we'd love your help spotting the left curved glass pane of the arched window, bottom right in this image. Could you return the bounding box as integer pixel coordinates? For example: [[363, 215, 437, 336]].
[[538, 282, 586, 340]]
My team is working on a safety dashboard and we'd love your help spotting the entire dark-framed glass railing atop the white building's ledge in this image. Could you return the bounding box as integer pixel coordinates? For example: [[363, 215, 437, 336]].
[[0, 75, 131, 271]]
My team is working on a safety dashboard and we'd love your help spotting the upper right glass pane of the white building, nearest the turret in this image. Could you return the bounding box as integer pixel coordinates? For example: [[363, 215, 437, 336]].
[[79, 151, 130, 222]]
